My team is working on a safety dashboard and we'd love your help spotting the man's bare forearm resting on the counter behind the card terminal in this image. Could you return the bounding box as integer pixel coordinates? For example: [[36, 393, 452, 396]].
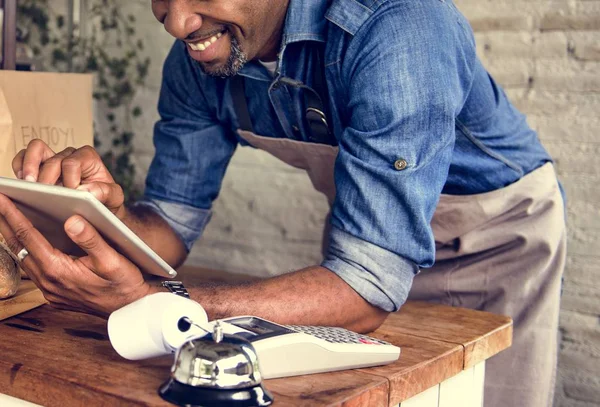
[[157, 266, 388, 332]]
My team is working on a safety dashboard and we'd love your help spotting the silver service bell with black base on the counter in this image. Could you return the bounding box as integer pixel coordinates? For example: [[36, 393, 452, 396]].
[[158, 322, 273, 407]]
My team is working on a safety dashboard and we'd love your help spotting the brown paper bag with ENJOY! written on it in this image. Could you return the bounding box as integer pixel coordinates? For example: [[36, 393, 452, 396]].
[[0, 70, 94, 178]]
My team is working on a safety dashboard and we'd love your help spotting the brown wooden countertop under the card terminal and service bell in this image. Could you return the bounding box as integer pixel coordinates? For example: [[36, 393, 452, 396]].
[[0, 272, 512, 407]]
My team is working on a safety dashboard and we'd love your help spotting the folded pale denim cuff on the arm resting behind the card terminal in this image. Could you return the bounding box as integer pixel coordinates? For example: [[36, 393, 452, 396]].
[[321, 226, 419, 312]]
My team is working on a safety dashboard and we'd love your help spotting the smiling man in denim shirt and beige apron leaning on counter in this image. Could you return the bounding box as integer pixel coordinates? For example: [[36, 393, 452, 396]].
[[0, 0, 565, 406]]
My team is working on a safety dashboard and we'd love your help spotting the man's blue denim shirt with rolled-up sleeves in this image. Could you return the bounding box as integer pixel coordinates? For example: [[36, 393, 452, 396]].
[[143, 0, 550, 311]]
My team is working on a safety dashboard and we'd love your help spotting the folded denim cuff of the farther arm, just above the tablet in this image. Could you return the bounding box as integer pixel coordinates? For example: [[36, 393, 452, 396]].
[[134, 196, 212, 253]]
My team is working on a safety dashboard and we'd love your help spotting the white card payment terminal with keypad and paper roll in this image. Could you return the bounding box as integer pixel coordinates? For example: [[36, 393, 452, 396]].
[[108, 292, 400, 378]]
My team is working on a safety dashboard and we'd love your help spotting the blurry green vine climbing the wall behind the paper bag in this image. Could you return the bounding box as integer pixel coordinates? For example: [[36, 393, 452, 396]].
[[17, 0, 150, 202]]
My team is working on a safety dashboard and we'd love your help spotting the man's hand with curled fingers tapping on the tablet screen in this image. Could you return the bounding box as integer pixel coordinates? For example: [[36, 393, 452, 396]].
[[12, 139, 125, 219]]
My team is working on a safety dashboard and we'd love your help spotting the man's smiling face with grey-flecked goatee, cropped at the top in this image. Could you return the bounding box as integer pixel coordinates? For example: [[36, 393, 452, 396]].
[[152, 0, 289, 76]]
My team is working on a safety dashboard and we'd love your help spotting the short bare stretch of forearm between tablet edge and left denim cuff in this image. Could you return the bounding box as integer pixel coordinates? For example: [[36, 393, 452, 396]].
[[122, 205, 187, 268]]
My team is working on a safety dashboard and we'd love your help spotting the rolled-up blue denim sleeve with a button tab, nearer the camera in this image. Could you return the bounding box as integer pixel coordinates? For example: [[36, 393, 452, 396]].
[[323, 2, 475, 311]]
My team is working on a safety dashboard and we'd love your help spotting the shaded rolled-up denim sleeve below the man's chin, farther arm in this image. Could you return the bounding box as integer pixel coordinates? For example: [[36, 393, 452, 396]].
[[144, 42, 237, 251]]
